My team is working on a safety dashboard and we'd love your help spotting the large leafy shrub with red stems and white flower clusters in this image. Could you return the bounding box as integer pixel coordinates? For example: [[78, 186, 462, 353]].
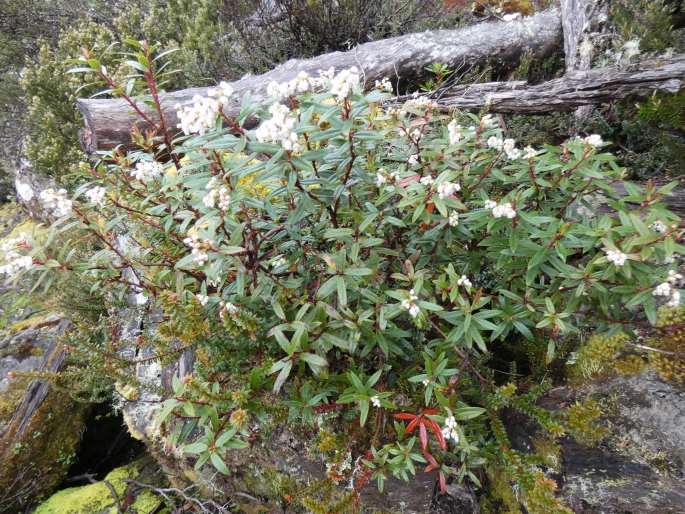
[[3, 43, 685, 500]]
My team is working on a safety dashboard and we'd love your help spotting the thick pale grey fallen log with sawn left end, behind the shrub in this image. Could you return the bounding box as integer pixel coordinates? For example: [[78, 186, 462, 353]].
[[77, 8, 561, 153]]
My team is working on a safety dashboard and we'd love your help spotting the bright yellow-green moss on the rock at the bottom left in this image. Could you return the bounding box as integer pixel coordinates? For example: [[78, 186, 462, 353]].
[[34, 463, 160, 514]]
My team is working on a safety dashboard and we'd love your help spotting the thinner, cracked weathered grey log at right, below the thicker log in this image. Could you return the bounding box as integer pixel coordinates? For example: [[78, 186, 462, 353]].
[[439, 54, 685, 114]]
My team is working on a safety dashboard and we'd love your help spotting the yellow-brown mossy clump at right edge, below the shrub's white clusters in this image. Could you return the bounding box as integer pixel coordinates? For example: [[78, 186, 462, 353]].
[[649, 307, 685, 383]]
